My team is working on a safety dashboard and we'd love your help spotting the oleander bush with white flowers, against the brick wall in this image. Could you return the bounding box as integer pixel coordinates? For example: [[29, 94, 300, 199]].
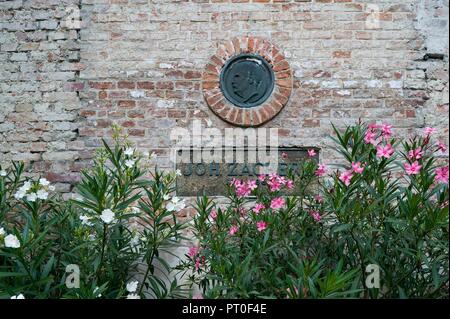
[[0, 130, 185, 299]]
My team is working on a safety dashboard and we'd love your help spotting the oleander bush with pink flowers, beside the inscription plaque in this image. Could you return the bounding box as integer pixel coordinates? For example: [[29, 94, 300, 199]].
[[179, 124, 449, 298]]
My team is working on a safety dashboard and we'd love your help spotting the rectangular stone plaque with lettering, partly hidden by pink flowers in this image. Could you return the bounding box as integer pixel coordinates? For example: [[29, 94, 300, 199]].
[[176, 147, 319, 196]]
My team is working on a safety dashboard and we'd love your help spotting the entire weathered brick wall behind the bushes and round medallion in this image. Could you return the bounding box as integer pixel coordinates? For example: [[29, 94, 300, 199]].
[[0, 0, 448, 196]]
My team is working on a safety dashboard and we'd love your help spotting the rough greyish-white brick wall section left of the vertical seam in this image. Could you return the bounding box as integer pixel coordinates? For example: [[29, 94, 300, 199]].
[[0, 0, 84, 192]]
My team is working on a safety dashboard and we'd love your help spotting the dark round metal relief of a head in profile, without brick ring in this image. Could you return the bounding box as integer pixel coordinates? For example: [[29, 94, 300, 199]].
[[220, 54, 275, 108]]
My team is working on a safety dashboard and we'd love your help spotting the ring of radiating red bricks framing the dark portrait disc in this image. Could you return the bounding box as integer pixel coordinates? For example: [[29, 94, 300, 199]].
[[202, 37, 293, 127]]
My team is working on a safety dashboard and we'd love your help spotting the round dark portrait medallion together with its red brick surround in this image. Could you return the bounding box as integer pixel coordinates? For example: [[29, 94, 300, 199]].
[[202, 37, 293, 127]]
